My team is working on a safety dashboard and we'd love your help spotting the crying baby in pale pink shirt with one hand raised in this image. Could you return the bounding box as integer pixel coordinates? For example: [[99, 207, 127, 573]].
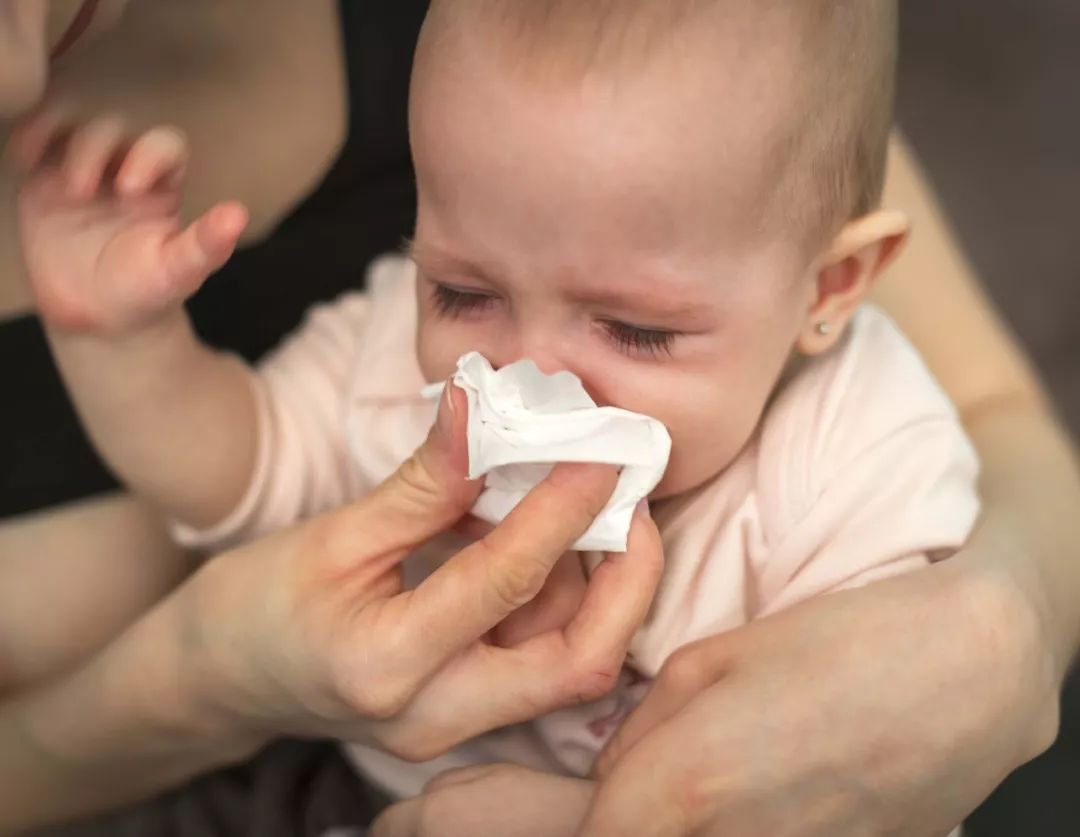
[[15, 0, 978, 829]]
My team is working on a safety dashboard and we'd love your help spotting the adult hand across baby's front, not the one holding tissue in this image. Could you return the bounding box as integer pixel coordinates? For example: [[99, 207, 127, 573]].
[[582, 555, 1057, 837]]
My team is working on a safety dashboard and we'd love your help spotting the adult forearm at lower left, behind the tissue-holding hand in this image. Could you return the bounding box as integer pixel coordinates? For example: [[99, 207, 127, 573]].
[[0, 591, 260, 835]]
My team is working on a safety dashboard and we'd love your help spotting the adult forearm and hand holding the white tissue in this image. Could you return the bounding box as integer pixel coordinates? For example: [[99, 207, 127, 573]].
[[0, 387, 663, 835]]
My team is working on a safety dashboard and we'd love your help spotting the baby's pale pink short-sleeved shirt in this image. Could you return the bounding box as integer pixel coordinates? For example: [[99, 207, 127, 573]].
[[172, 253, 978, 796]]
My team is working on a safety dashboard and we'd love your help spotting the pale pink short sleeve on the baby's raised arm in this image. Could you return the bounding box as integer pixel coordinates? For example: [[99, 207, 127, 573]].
[[173, 293, 368, 551]]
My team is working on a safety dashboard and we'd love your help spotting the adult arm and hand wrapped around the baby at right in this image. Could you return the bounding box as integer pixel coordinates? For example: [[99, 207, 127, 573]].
[[582, 132, 1080, 837]]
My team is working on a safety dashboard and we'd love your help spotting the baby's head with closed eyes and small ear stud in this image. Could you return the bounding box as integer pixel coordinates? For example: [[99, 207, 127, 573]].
[[410, 0, 906, 497]]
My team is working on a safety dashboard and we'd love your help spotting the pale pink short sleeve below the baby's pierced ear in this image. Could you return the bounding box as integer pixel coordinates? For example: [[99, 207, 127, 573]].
[[758, 414, 980, 616]]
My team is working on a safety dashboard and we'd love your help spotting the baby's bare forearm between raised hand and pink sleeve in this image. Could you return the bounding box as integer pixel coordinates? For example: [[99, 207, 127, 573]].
[[50, 311, 257, 526]]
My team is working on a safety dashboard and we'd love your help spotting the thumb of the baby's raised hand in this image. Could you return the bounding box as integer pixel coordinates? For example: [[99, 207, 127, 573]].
[[161, 202, 247, 298]]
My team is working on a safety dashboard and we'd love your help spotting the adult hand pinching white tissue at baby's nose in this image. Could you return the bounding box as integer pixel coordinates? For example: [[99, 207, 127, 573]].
[[176, 387, 662, 759]]
